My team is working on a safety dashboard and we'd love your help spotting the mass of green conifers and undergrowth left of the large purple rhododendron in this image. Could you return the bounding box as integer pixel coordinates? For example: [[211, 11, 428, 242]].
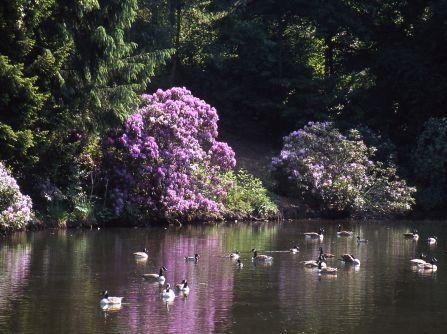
[[0, 0, 171, 224]]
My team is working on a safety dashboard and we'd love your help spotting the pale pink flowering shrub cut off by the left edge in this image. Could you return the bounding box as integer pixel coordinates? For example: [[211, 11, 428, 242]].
[[0, 162, 32, 229]]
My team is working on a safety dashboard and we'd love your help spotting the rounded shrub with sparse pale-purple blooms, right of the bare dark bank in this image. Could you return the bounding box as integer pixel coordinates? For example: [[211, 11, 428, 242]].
[[272, 122, 416, 216]]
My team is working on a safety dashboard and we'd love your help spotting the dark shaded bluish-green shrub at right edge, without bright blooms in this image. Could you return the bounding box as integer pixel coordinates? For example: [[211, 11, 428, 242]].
[[413, 118, 447, 210]]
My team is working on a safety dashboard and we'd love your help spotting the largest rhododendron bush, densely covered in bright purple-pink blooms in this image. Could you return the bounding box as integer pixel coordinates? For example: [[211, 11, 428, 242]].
[[106, 87, 236, 219]]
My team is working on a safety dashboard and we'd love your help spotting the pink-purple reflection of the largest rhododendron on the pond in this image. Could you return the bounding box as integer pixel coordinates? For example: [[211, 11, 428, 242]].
[[123, 231, 234, 333]]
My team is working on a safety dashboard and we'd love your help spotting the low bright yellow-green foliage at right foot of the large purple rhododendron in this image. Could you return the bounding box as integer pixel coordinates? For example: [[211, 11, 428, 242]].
[[224, 169, 278, 217]]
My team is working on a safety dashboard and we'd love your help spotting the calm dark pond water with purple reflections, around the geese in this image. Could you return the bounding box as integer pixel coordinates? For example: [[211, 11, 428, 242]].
[[0, 222, 447, 334]]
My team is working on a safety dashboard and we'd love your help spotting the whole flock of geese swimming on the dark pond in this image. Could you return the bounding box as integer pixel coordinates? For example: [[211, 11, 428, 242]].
[[100, 225, 438, 310]]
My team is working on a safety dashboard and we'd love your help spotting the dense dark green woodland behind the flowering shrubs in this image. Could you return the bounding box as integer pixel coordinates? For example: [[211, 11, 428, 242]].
[[0, 0, 447, 230]]
